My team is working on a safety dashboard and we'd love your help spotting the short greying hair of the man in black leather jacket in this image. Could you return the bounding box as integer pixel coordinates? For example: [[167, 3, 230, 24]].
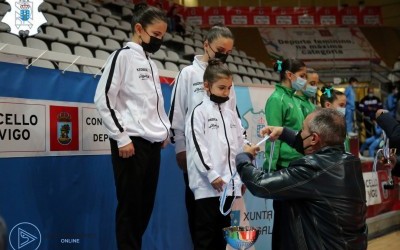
[[308, 108, 346, 146]]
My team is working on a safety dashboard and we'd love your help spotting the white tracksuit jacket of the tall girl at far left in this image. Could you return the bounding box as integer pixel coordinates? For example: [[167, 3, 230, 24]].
[[94, 42, 170, 147]]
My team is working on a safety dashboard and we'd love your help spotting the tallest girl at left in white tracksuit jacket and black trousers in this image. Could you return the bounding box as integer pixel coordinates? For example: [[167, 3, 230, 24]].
[[95, 5, 170, 250]]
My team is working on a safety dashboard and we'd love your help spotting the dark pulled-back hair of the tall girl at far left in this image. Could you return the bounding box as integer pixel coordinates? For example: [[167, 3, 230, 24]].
[[131, 3, 168, 34]]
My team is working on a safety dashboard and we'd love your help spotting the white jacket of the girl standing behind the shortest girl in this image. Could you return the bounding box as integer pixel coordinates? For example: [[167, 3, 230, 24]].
[[169, 56, 236, 153]]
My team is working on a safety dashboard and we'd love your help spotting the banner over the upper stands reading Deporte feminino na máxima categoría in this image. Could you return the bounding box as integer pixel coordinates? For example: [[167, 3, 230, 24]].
[[259, 27, 380, 66]]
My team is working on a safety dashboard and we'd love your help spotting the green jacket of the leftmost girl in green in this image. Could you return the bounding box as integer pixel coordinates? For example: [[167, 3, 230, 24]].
[[264, 85, 304, 170]]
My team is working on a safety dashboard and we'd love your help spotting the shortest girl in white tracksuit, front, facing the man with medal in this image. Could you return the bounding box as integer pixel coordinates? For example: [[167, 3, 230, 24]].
[[185, 60, 256, 250]]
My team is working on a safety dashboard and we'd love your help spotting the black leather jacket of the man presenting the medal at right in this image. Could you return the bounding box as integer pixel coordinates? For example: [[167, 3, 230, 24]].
[[236, 143, 367, 249]]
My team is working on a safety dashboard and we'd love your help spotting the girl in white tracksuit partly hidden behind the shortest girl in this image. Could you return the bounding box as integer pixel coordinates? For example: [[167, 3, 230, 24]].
[[169, 26, 240, 239]]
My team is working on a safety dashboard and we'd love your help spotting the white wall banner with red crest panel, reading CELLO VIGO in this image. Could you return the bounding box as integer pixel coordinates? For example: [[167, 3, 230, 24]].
[[0, 97, 110, 158]]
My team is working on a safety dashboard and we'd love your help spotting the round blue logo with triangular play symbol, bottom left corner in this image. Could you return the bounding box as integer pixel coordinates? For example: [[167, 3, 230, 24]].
[[9, 222, 42, 250]]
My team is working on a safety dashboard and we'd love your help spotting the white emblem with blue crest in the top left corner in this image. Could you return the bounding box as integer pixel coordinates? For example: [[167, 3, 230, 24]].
[[1, 0, 47, 36]]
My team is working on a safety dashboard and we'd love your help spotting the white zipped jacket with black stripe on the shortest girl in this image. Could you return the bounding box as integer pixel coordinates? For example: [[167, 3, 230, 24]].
[[185, 95, 245, 200]]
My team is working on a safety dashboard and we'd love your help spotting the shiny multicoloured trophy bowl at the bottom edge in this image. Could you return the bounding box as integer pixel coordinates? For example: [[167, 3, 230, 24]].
[[223, 226, 260, 250]]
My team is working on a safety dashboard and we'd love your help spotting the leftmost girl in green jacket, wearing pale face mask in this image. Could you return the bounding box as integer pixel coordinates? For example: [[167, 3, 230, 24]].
[[264, 59, 307, 249]]
